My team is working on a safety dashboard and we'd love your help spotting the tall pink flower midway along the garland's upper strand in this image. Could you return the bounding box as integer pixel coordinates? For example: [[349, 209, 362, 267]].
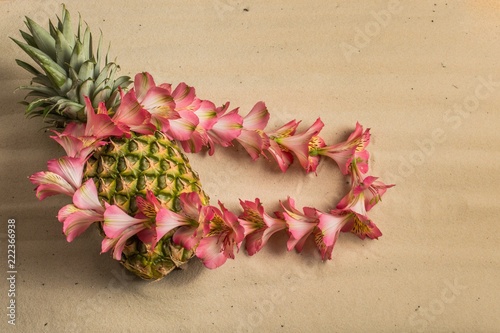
[[236, 102, 269, 160]]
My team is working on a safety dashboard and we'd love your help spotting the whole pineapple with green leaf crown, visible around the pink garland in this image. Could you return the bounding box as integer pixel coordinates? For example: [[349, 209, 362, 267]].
[[14, 7, 208, 280]]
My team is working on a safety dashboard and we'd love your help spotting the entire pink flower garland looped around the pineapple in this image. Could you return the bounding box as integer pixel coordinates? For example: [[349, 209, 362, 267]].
[[30, 73, 393, 268]]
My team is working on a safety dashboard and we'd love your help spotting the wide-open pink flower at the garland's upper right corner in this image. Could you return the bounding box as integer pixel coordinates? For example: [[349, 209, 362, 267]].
[[316, 123, 370, 175]]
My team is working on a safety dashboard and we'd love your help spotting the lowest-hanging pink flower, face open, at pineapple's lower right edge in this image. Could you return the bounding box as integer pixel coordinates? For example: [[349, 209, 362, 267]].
[[196, 202, 244, 269]]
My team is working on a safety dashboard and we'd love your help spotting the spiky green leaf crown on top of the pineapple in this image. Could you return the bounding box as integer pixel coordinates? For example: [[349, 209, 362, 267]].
[[11, 6, 131, 127]]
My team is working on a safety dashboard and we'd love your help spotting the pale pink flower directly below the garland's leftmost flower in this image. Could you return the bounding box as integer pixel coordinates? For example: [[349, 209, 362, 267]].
[[57, 179, 104, 242]]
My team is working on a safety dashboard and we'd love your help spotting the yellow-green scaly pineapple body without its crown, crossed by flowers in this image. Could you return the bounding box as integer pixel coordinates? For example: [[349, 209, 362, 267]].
[[84, 132, 209, 280]]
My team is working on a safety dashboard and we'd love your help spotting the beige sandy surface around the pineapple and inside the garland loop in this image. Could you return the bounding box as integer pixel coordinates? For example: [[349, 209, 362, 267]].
[[0, 0, 500, 332]]
